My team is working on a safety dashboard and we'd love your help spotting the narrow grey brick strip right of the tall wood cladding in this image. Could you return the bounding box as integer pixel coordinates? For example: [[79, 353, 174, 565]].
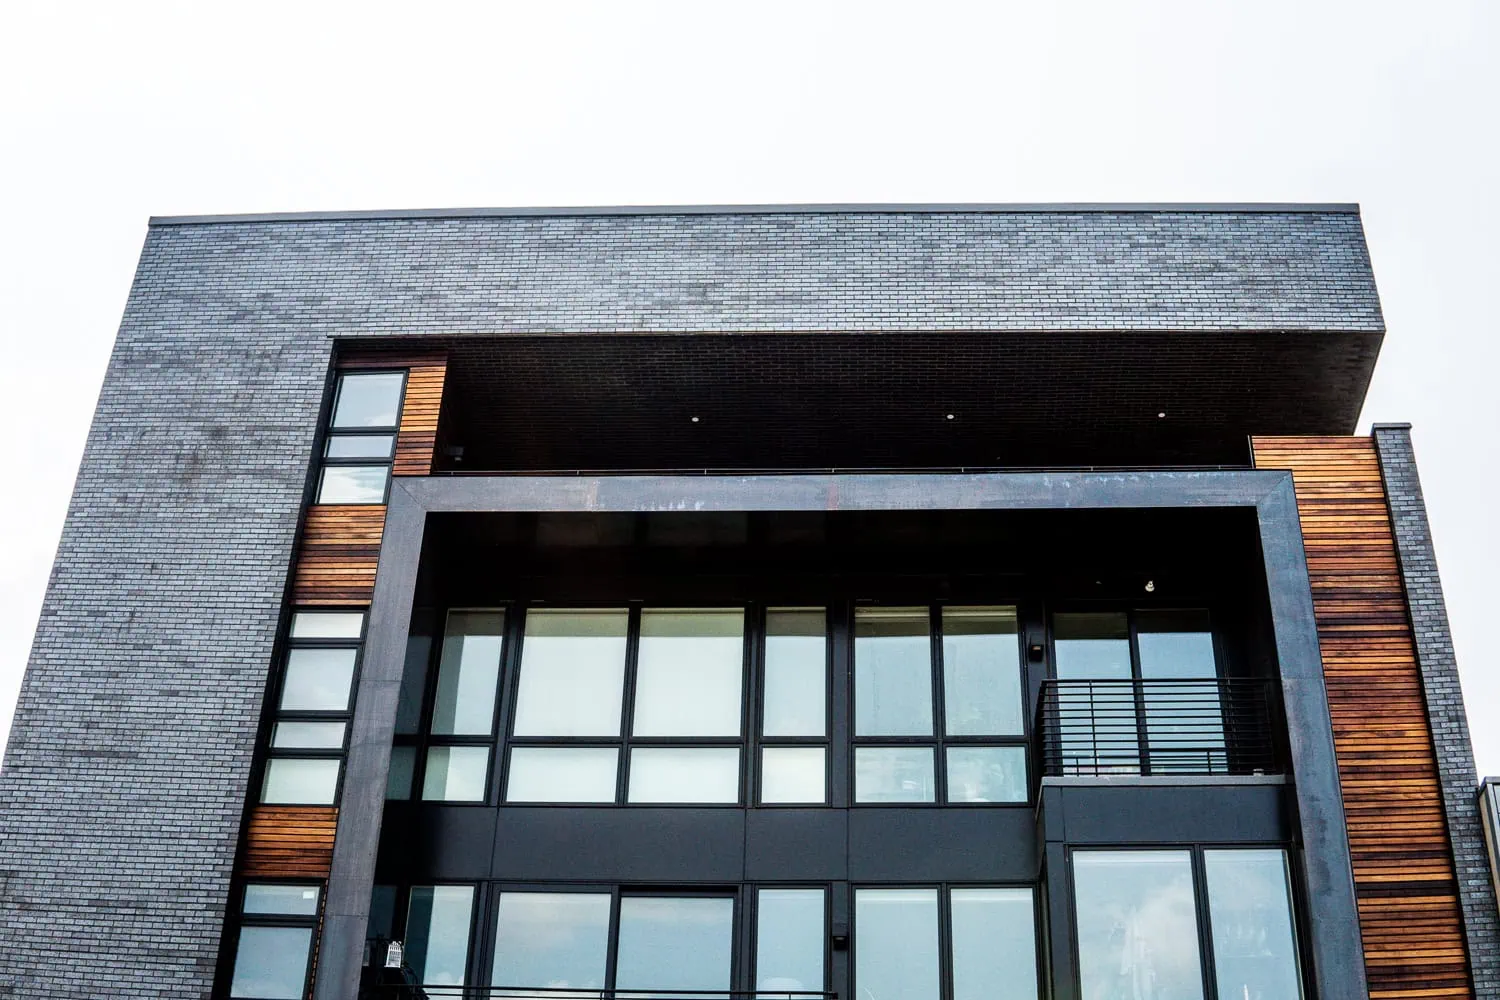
[[1373, 424, 1500, 997]]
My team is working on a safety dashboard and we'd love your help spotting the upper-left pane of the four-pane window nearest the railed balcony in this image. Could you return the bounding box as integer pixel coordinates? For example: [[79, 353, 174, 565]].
[[854, 607, 933, 736]]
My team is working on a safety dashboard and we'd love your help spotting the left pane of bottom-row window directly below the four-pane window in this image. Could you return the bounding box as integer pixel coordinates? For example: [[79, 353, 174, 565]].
[[854, 889, 938, 1000]]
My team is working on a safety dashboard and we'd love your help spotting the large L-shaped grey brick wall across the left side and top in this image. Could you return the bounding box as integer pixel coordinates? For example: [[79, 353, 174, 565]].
[[0, 211, 1383, 999]]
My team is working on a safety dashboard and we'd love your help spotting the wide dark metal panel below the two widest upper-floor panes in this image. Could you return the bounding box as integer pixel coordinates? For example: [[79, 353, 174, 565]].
[[491, 807, 746, 883]]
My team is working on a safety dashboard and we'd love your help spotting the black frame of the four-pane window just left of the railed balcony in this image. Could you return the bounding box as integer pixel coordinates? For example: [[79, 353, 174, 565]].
[[848, 600, 1034, 810]]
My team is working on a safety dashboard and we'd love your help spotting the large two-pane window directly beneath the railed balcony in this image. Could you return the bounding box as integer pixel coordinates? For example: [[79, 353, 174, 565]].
[[1073, 849, 1302, 1000]]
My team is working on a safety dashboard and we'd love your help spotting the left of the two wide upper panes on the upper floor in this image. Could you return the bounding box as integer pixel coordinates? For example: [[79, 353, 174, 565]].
[[516, 610, 630, 736]]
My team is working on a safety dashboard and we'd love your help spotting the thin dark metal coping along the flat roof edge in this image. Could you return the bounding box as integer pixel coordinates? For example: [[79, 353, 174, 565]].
[[150, 201, 1359, 226]]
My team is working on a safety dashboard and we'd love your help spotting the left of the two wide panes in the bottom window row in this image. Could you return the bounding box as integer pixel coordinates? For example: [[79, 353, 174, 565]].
[[489, 892, 609, 990]]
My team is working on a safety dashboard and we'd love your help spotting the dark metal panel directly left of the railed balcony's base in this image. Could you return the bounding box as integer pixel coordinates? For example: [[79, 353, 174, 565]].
[[849, 807, 1037, 882]]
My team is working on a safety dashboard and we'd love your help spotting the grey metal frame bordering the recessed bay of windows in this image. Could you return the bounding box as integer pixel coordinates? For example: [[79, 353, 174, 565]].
[[315, 471, 1367, 1000]]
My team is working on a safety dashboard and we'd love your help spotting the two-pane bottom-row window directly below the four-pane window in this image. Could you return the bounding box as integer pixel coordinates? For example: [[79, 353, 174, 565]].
[[854, 886, 1032, 1000]]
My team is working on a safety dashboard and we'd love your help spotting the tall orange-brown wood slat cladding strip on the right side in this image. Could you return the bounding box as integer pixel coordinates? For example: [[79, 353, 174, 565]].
[[1253, 438, 1473, 1000]]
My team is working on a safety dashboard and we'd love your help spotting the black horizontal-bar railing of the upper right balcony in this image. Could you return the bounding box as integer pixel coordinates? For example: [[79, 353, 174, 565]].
[[1035, 678, 1283, 777]]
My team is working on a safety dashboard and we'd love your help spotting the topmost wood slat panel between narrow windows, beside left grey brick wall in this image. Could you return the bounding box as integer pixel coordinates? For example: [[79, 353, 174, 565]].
[[293, 504, 386, 606]]
